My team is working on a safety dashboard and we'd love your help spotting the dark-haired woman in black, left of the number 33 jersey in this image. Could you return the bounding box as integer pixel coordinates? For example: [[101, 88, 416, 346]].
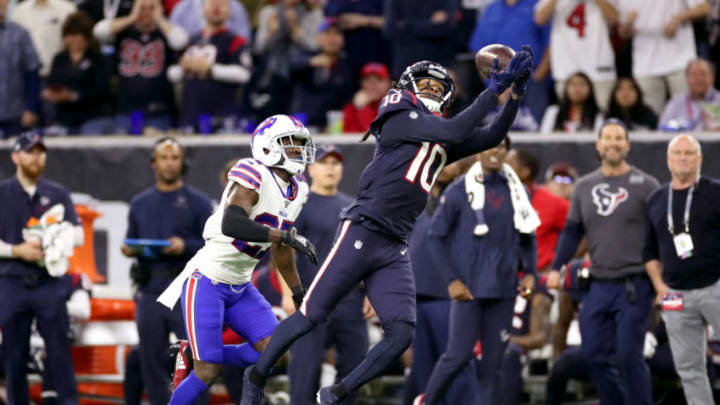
[[42, 11, 113, 135]]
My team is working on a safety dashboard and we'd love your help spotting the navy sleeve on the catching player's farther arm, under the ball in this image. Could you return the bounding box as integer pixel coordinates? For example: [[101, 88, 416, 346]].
[[448, 95, 521, 163]]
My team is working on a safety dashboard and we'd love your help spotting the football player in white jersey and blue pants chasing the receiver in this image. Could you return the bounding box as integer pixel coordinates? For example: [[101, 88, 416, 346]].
[[163, 115, 317, 405]]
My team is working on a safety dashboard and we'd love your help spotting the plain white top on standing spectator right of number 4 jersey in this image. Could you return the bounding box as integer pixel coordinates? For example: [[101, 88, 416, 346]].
[[620, 0, 705, 77]]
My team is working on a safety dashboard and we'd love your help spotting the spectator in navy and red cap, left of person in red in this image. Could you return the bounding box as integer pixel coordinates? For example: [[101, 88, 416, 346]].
[[290, 19, 355, 128]]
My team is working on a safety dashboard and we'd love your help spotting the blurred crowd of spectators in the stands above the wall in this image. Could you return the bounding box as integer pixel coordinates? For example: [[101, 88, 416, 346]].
[[0, 0, 720, 138]]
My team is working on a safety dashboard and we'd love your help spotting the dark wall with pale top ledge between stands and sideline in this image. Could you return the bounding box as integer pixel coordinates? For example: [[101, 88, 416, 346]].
[[0, 133, 720, 201]]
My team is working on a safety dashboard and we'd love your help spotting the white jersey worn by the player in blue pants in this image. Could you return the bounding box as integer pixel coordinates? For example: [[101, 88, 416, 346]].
[[186, 159, 309, 284]]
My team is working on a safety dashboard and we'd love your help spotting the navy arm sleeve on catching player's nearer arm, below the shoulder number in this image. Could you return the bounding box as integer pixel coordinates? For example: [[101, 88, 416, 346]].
[[381, 90, 499, 144]]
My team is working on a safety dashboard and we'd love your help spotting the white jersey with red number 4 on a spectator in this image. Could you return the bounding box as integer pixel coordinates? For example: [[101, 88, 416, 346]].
[[535, 0, 617, 81]]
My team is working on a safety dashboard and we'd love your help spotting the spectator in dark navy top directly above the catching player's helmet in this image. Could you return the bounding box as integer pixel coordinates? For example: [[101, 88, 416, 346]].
[[385, 0, 458, 77]]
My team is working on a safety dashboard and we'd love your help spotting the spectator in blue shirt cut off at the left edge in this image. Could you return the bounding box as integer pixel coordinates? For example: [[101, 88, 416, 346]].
[[0, 0, 40, 139]]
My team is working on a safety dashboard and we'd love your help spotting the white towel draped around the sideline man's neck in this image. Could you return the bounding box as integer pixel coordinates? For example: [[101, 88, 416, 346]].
[[465, 162, 540, 236]]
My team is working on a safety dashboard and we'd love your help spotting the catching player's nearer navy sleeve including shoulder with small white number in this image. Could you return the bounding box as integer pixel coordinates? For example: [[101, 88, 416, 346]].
[[370, 89, 500, 146]]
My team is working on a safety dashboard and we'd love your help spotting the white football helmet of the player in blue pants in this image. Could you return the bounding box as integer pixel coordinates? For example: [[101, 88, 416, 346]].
[[250, 114, 315, 175]]
